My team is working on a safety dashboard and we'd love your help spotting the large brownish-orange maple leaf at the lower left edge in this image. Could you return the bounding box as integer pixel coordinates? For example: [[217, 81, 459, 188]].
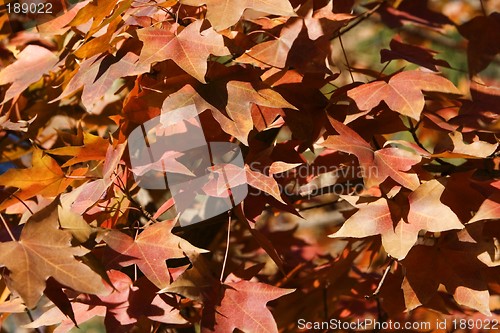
[[0, 200, 106, 308]]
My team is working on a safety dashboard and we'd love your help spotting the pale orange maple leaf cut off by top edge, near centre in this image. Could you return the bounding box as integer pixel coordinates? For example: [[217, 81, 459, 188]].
[[180, 0, 295, 31]]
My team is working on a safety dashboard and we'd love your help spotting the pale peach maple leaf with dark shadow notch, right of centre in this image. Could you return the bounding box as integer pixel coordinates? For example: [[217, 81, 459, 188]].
[[329, 179, 464, 259]]
